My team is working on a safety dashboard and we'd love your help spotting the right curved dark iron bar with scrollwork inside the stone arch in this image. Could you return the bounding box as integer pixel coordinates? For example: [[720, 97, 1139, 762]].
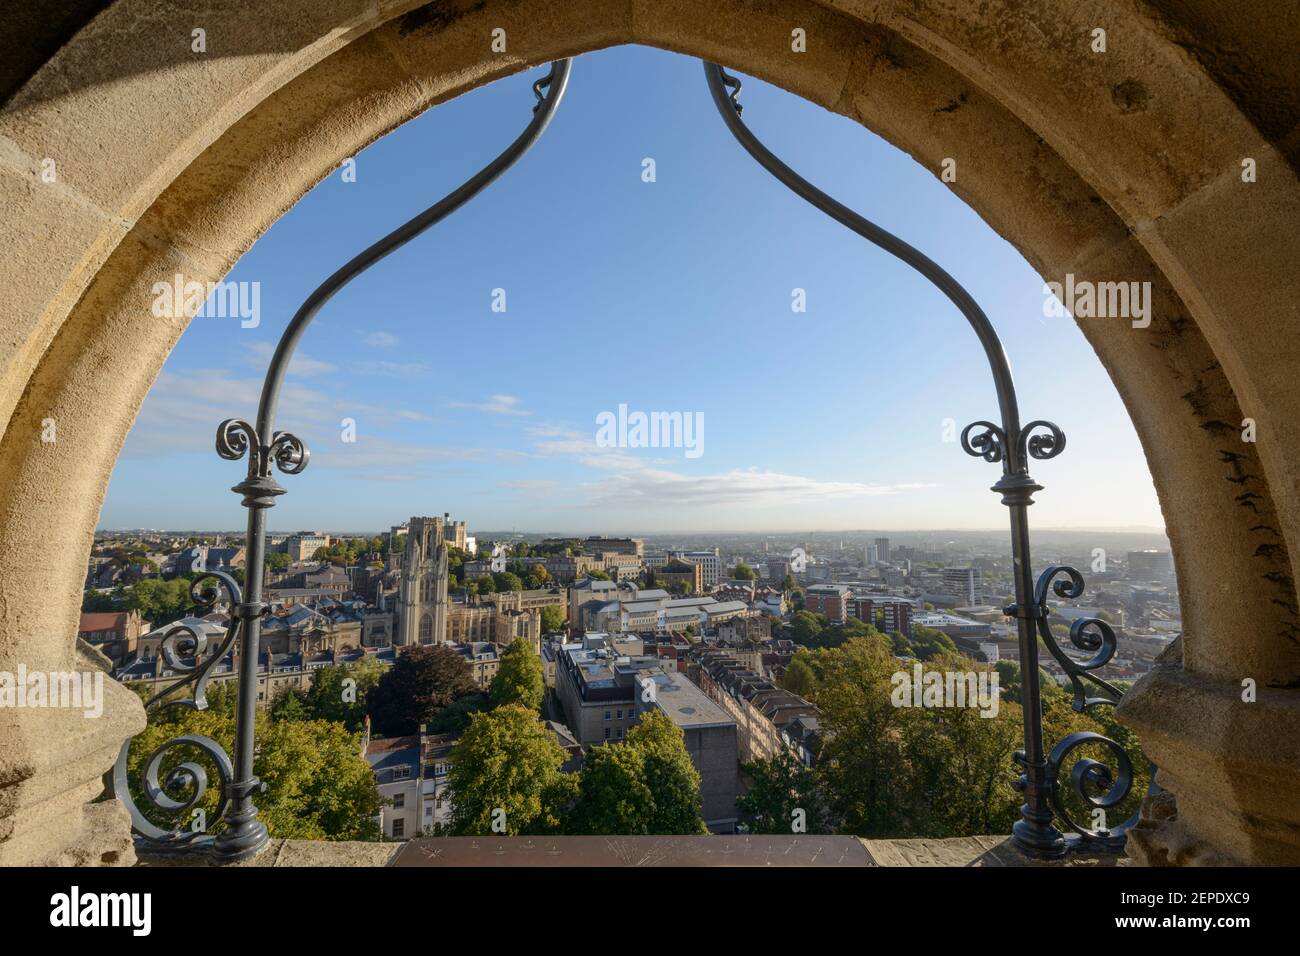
[[705, 62, 1132, 857]]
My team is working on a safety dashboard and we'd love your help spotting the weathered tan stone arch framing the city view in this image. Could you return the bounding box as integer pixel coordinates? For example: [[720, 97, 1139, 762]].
[[0, 0, 1300, 861]]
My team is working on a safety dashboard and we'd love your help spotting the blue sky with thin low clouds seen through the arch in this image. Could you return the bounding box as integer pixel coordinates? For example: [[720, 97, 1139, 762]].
[[100, 47, 1164, 533]]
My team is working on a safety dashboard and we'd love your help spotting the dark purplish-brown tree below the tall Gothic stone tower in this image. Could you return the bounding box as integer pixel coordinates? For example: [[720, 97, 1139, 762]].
[[368, 644, 475, 736]]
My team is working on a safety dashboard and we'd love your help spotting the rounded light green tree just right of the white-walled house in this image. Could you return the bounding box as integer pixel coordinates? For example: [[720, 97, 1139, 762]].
[[447, 704, 573, 836]]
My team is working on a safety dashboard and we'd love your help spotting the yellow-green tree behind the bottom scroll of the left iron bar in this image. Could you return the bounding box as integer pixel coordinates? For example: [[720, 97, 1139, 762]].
[[127, 707, 381, 840]]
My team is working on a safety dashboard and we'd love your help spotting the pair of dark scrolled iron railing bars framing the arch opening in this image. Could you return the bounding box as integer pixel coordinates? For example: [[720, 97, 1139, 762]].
[[108, 60, 1136, 862]]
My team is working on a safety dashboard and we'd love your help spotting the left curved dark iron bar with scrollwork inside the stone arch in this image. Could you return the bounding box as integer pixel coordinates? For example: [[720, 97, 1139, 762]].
[[108, 59, 572, 862]]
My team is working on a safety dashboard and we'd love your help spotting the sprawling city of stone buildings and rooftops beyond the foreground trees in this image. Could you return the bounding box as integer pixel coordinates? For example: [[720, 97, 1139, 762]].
[[79, 515, 1180, 840]]
